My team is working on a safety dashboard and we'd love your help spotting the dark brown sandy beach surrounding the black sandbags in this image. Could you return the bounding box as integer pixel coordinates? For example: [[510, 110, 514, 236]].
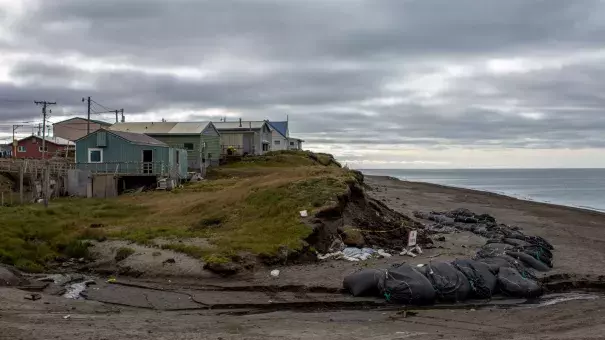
[[0, 176, 605, 340]]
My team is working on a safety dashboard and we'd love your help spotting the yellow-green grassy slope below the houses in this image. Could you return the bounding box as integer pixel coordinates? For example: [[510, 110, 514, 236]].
[[0, 152, 352, 270]]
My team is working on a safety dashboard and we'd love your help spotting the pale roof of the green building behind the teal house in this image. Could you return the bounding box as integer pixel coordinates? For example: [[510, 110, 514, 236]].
[[109, 122, 212, 135]]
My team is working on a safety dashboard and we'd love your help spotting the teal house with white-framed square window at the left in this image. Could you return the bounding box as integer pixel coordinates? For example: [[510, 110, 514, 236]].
[[76, 129, 187, 179]]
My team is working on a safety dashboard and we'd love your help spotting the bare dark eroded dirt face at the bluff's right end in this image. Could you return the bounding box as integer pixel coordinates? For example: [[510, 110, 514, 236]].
[[306, 173, 432, 253]]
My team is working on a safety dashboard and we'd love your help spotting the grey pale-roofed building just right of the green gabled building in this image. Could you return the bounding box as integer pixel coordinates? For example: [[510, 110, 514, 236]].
[[214, 119, 273, 155]]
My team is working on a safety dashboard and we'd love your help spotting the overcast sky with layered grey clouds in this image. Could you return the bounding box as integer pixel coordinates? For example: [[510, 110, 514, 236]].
[[0, 0, 605, 168]]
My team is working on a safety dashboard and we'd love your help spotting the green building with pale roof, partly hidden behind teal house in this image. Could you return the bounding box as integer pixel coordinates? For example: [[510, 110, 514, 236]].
[[109, 122, 220, 171]]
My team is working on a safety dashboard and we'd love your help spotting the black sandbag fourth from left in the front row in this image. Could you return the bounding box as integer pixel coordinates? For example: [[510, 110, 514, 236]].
[[452, 259, 498, 299]]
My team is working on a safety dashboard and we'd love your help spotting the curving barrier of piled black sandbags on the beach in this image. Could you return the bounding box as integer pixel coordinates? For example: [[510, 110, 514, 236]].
[[343, 209, 554, 305]]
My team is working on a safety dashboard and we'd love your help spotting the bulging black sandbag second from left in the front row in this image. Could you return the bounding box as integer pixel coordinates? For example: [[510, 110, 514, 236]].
[[378, 264, 435, 305]]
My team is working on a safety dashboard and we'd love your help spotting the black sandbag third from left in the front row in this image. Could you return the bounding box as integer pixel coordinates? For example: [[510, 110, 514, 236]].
[[425, 262, 471, 302]]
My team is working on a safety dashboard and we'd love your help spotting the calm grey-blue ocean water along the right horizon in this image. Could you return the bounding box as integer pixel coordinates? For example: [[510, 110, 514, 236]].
[[361, 169, 605, 211]]
